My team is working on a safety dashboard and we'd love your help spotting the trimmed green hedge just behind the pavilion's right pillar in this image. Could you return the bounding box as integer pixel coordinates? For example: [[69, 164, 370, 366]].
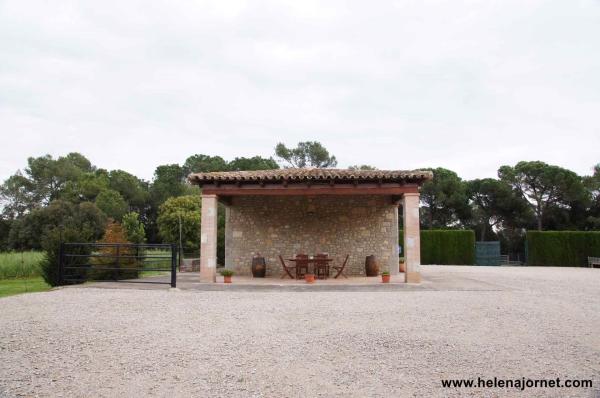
[[400, 230, 475, 265]]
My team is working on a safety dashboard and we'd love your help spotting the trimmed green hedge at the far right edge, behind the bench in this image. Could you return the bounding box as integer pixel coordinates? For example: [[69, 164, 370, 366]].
[[527, 231, 600, 267]]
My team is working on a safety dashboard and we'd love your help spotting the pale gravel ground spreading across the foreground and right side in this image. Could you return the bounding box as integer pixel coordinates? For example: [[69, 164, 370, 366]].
[[0, 266, 600, 397]]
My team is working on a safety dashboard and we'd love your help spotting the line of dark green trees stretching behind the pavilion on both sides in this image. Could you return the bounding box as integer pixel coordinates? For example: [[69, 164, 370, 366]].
[[0, 142, 600, 260]]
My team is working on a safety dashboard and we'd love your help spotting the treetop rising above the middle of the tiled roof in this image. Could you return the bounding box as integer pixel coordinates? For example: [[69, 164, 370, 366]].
[[275, 141, 337, 168]]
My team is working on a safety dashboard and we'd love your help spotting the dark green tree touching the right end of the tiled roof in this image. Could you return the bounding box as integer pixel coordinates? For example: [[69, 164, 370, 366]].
[[421, 167, 471, 229]]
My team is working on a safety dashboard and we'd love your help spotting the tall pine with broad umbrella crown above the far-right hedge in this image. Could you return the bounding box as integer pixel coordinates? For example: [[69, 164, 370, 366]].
[[498, 161, 589, 231]]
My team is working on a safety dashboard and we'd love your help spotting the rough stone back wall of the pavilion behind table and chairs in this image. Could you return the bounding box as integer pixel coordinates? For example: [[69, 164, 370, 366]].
[[225, 195, 398, 277]]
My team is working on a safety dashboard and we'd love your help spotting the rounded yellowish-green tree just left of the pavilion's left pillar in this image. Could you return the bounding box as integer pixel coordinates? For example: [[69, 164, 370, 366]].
[[157, 195, 201, 251]]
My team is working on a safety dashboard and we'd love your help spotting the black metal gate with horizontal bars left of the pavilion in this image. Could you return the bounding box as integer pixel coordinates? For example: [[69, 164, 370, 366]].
[[59, 243, 177, 287]]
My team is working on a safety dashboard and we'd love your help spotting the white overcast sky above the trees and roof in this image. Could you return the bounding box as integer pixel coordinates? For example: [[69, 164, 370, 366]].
[[0, 0, 600, 180]]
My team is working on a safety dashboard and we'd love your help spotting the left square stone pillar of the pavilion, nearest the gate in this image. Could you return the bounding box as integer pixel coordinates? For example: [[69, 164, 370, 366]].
[[200, 195, 217, 282]]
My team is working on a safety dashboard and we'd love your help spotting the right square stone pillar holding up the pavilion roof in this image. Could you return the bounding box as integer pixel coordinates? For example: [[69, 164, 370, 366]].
[[402, 193, 421, 283]]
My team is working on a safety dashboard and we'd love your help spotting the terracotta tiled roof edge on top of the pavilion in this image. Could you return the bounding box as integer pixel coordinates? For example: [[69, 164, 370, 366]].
[[188, 168, 433, 184]]
